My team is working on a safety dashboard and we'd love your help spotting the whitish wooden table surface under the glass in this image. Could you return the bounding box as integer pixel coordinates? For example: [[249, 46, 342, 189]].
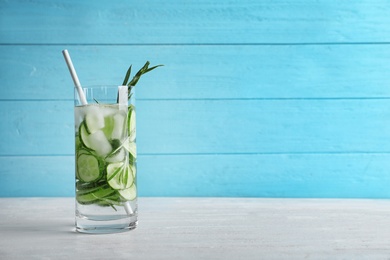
[[0, 198, 390, 260]]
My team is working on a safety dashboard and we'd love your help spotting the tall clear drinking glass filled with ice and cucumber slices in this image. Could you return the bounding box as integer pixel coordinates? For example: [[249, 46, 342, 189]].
[[74, 86, 137, 233]]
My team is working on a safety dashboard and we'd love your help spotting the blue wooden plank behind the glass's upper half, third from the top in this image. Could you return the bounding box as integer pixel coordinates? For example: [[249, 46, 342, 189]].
[[0, 99, 390, 155]]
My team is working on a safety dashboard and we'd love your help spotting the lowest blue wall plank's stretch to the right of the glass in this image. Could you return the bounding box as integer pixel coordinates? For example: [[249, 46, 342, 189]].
[[138, 154, 390, 198]]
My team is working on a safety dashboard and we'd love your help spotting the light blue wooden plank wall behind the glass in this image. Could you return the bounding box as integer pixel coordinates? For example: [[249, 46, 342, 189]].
[[0, 0, 390, 198]]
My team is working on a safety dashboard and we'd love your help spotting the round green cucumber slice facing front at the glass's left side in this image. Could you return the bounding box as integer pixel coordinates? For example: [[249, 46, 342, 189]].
[[77, 153, 102, 182]]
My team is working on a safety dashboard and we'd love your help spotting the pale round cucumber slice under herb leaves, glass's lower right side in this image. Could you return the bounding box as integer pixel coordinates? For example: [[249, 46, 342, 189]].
[[107, 162, 134, 190]]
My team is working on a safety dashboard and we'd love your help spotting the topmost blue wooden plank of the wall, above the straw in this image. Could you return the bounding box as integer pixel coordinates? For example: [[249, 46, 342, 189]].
[[0, 0, 390, 44]]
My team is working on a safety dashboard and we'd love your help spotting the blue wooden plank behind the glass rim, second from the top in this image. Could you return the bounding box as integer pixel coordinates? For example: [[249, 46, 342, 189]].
[[0, 44, 390, 100]]
